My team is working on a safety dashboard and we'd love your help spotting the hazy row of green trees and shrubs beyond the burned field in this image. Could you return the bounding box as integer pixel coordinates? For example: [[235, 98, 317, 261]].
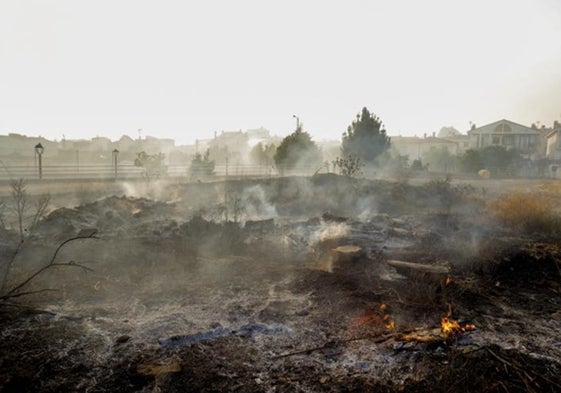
[[135, 107, 539, 179]]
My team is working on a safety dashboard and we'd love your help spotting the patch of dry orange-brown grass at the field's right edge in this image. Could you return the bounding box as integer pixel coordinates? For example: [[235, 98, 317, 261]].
[[489, 192, 561, 235]]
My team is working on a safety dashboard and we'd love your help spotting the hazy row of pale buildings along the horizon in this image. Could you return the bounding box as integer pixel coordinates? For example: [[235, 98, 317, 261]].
[[0, 119, 561, 165]]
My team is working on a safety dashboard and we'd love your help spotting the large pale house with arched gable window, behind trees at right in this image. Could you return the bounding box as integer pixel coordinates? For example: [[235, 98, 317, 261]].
[[467, 119, 540, 158]]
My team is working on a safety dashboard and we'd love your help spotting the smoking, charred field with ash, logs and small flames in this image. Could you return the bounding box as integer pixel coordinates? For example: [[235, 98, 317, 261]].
[[0, 175, 561, 392]]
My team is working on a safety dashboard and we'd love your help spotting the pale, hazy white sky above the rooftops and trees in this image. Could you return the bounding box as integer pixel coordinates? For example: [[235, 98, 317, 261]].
[[0, 0, 561, 143]]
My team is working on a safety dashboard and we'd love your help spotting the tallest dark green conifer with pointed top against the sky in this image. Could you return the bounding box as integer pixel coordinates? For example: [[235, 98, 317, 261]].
[[341, 108, 391, 165]]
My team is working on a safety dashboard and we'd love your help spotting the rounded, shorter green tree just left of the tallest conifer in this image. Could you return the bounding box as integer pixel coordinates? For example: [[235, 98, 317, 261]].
[[274, 125, 322, 173]]
